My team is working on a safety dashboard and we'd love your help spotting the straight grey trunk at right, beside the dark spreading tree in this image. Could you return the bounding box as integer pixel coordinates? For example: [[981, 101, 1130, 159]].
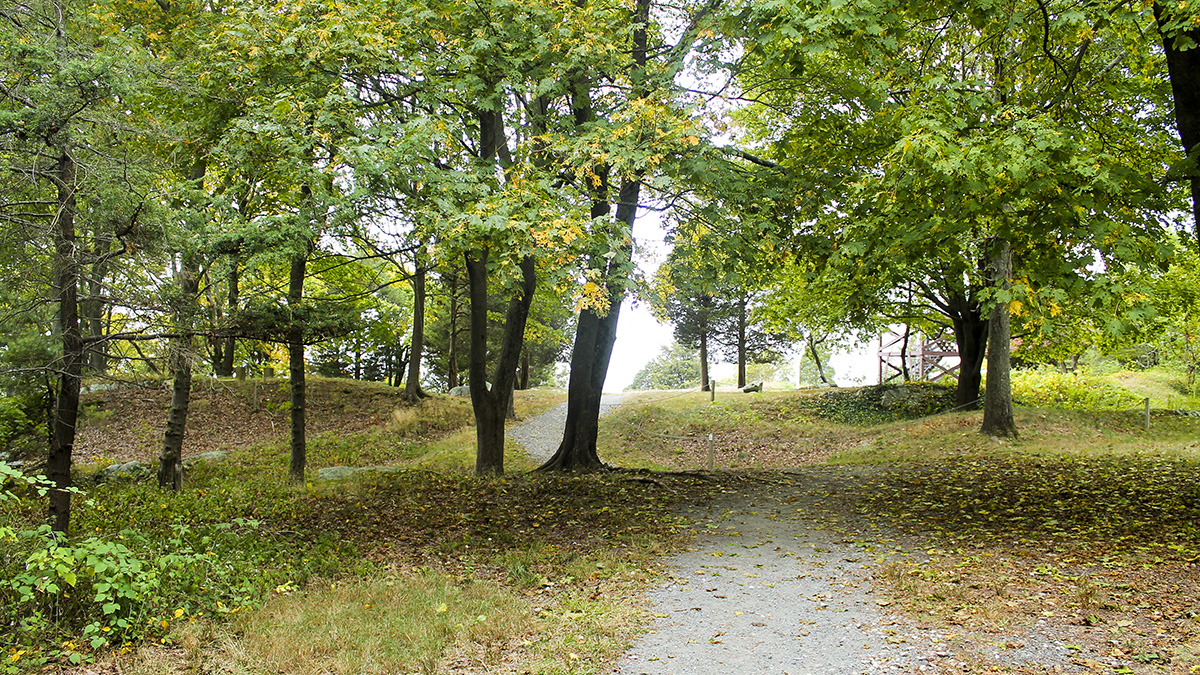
[[979, 241, 1016, 437]]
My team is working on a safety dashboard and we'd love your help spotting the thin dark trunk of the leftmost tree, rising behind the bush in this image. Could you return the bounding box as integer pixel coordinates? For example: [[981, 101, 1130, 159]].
[[46, 149, 84, 534]]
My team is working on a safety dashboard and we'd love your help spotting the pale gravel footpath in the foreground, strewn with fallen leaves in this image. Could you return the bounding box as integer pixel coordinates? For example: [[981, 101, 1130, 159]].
[[613, 468, 952, 675]]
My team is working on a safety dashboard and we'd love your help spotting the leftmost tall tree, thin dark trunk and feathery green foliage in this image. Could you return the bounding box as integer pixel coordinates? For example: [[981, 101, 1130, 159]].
[[0, 0, 151, 532]]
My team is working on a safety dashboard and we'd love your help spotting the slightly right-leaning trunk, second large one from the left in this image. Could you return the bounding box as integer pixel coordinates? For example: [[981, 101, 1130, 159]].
[[158, 255, 200, 492]]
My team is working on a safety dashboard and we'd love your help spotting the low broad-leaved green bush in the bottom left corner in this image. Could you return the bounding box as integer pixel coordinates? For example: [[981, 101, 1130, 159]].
[[0, 462, 277, 674]]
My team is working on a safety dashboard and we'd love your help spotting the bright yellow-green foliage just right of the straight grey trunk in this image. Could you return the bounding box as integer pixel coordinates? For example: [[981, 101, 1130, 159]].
[[1012, 368, 1141, 410]]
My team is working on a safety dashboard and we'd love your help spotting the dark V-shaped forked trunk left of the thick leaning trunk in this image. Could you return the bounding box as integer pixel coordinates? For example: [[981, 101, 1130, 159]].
[[466, 251, 538, 476]]
